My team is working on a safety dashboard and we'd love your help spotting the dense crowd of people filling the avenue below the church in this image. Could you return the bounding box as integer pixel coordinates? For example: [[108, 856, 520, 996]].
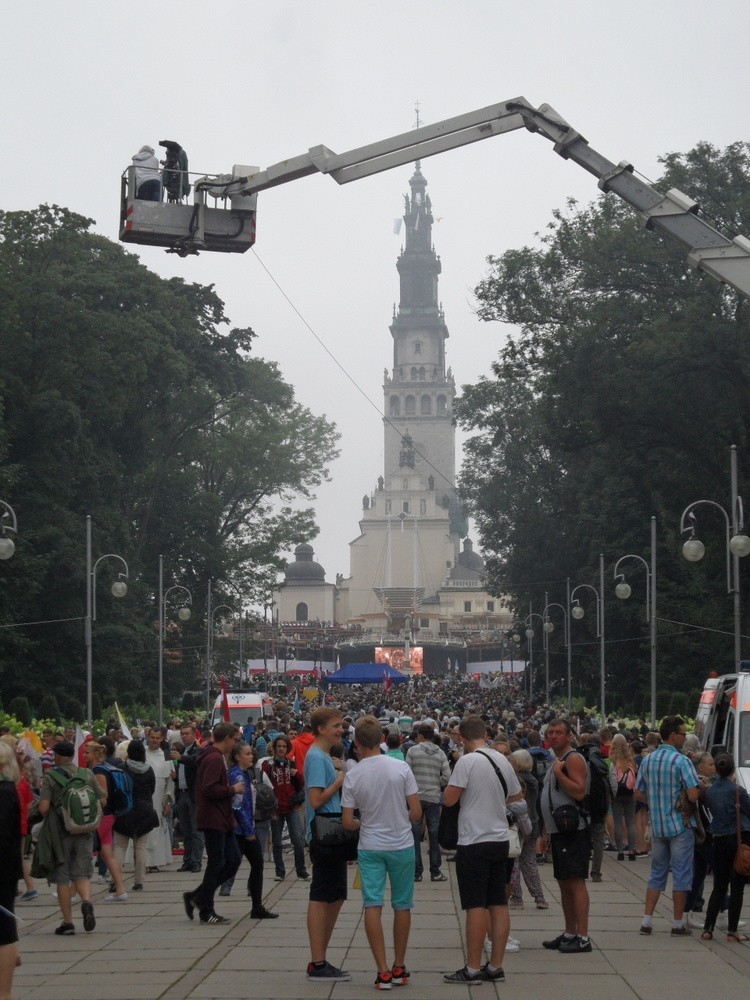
[[0, 675, 750, 1000]]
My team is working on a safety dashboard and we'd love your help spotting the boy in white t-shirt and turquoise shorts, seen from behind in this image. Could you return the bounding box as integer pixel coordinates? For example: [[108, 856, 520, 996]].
[[341, 715, 422, 990]]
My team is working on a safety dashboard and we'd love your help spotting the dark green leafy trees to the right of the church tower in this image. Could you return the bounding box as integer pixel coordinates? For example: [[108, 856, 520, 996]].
[[457, 143, 750, 711]]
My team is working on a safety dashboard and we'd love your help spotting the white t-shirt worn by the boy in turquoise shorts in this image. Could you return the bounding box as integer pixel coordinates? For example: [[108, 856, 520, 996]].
[[341, 754, 418, 851]]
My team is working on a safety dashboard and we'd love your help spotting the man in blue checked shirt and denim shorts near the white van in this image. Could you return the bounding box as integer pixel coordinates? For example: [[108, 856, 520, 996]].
[[635, 715, 699, 937]]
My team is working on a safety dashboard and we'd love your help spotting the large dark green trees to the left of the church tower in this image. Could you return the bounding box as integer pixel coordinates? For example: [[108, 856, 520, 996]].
[[0, 206, 337, 711]]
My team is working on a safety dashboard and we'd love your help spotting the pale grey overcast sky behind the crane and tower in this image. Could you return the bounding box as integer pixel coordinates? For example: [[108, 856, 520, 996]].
[[0, 0, 750, 600]]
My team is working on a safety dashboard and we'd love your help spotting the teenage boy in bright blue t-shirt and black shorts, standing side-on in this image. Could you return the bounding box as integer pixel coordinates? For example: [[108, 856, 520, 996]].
[[304, 708, 352, 982]]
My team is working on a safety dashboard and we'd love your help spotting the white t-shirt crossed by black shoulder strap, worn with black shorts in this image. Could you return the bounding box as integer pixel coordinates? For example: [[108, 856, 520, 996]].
[[448, 748, 521, 847]]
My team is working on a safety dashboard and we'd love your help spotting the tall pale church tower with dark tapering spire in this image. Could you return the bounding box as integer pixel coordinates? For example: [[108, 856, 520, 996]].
[[337, 162, 466, 627]]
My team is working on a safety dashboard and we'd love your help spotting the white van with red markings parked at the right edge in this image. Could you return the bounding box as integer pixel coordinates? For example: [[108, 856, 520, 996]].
[[695, 660, 750, 792]]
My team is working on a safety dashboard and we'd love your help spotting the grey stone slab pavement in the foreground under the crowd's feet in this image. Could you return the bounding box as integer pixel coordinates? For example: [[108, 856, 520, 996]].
[[13, 854, 750, 1000]]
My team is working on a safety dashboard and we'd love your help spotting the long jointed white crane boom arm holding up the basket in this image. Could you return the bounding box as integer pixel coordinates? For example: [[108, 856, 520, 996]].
[[228, 97, 750, 298]]
